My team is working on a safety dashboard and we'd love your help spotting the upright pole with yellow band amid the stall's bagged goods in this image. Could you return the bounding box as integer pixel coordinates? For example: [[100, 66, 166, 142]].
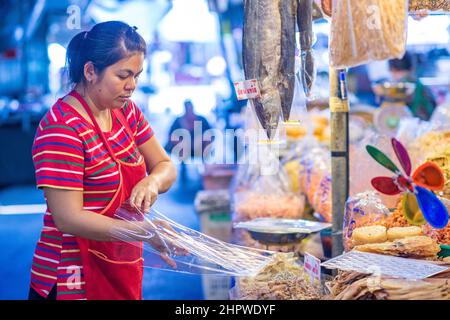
[[329, 68, 349, 257]]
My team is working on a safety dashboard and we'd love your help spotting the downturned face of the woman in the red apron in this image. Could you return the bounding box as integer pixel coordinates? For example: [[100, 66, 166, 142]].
[[92, 52, 144, 109]]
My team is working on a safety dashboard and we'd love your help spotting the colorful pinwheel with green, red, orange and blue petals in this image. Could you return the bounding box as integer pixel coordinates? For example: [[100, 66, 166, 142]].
[[366, 138, 449, 229]]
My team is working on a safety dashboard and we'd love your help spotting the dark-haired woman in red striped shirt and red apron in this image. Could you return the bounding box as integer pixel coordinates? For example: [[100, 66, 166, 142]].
[[30, 21, 176, 300]]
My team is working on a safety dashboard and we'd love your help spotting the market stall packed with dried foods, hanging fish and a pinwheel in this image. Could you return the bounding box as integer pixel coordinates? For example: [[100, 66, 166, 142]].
[[221, 0, 450, 299]]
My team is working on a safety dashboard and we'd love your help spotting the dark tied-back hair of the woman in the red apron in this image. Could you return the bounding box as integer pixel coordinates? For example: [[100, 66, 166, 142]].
[[67, 21, 147, 83]]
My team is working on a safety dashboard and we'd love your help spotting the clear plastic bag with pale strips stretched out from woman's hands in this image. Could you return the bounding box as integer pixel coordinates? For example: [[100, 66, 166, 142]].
[[111, 202, 273, 276]]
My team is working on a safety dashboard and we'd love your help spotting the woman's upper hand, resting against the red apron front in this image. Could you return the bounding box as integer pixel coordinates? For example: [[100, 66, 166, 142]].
[[130, 175, 159, 213]]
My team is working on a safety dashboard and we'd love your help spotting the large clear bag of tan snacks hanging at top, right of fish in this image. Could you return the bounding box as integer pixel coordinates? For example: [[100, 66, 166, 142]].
[[329, 0, 408, 69]]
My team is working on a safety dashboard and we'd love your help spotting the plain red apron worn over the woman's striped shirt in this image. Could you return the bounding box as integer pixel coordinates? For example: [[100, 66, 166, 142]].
[[70, 91, 146, 300]]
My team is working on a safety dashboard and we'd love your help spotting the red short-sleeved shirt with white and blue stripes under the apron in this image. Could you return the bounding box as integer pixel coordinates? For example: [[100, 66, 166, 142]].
[[31, 100, 153, 300]]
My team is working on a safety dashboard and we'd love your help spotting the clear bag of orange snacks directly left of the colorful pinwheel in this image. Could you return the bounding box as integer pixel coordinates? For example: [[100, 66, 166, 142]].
[[343, 191, 389, 251]]
